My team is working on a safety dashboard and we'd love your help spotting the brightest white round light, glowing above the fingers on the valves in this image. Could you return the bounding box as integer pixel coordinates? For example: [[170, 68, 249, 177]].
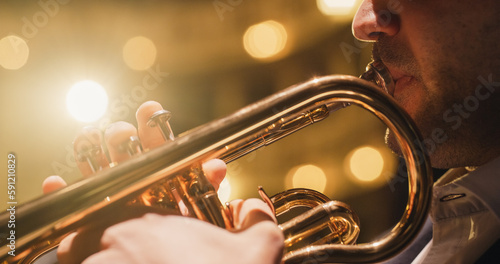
[[66, 80, 108, 122]]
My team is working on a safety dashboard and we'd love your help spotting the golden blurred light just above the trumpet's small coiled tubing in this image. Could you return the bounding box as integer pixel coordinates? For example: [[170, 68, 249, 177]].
[[286, 164, 327, 192]]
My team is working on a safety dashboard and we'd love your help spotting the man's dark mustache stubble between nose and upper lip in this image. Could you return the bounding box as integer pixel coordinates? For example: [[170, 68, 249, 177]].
[[372, 38, 420, 78]]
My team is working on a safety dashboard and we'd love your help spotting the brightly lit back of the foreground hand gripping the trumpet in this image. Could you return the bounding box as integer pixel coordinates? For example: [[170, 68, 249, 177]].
[[83, 210, 284, 264]]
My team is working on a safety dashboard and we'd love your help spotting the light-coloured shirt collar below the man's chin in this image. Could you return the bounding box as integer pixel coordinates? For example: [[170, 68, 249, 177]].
[[412, 157, 500, 264]]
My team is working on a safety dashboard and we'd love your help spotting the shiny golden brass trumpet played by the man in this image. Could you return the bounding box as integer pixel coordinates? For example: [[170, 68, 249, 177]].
[[0, 62, 432, 263]]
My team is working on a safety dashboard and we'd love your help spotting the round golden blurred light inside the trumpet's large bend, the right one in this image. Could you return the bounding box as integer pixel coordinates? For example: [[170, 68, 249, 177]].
[[347, 146, 384, 182]]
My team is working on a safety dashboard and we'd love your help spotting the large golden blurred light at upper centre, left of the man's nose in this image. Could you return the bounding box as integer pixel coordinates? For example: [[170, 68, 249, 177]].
[[243, 20, 287, 59]]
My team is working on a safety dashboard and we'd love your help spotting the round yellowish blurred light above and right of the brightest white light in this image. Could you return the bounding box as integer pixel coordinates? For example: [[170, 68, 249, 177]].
[[123, 36, 156, 71]]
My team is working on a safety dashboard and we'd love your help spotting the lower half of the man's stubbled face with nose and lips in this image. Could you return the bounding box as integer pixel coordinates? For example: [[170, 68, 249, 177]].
[[353, 0, 500, 168]]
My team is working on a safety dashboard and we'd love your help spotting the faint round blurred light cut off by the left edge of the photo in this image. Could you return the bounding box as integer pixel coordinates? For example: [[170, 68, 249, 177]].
[[0, 35, 29, 70]]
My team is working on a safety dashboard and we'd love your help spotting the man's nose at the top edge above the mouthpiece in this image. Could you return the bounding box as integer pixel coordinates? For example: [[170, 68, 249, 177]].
[[352, 0, 400, 41]]
